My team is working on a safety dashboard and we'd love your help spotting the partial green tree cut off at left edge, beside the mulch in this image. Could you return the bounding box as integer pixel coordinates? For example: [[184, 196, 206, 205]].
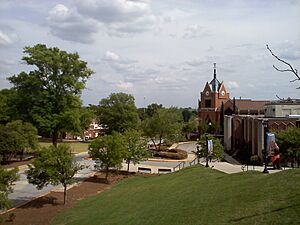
[[0, 167, 19, 209]]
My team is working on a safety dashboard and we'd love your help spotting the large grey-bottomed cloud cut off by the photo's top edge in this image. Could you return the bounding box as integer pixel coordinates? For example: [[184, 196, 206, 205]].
[[76, 0, 156, 37]]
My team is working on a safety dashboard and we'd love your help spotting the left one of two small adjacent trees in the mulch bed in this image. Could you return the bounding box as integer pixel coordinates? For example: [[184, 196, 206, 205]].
[[89, 132, 126, 182]]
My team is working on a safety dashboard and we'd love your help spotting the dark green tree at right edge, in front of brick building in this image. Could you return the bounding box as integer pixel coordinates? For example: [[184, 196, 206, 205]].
[[276, 127, 300, 165]]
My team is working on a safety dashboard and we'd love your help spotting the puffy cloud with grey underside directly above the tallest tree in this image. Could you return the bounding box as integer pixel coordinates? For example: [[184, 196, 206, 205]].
[[47, 4, 98, 43]]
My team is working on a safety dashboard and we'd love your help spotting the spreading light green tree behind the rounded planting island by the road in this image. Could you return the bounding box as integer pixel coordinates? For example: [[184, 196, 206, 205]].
[[142, 108, 182, 150]]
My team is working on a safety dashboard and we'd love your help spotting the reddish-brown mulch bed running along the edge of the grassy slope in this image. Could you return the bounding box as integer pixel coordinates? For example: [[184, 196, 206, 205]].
[[1, 172, 153, 225]]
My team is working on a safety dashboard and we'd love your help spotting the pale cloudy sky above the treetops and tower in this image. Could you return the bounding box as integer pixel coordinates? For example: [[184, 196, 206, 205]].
[[0, 0, 300, 108]]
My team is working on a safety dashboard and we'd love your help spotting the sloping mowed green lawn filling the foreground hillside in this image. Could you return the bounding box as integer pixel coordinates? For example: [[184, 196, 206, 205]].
[[53, 166, 300, 225]]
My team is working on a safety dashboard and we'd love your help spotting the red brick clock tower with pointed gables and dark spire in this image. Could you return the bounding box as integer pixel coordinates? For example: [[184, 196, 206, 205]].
[[198, 63, 229, 124]]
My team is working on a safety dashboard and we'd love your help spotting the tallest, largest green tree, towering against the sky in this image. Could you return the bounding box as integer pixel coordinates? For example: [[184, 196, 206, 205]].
[[8, 44, 93, 146]]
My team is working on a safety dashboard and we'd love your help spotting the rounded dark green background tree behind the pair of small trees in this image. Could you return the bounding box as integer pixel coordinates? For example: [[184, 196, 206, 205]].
[[97, 93, 139, 133]]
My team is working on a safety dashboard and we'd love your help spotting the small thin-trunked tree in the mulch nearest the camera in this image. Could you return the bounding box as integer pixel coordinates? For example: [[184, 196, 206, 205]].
[[26, 144, 83, 204]]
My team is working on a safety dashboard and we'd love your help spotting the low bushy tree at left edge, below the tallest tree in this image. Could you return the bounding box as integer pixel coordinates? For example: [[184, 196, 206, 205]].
[[0, 120, 38, 163]]
